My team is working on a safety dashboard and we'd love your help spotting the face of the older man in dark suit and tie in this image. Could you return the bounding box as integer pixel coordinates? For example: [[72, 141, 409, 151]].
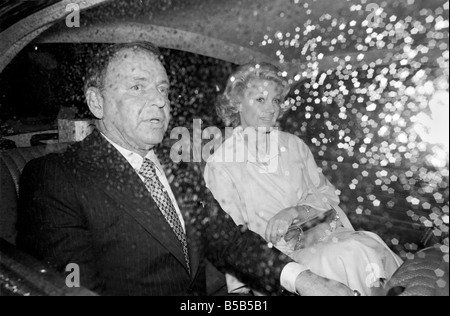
[[102, 49, 170, 151]]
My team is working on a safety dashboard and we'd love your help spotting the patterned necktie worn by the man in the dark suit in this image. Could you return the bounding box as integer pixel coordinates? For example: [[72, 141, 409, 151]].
[[139, 158, 191, 274]]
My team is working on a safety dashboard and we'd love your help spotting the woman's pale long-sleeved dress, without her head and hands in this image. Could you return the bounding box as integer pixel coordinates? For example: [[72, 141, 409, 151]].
[[204, 127, 402, 295]]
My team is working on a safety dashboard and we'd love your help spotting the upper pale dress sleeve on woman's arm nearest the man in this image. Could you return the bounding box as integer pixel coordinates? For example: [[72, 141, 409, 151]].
[[204, 162, 248, 225]]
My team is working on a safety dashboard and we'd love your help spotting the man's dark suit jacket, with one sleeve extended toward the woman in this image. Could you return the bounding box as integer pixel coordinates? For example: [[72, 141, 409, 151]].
[[17, 131, 291, 295]]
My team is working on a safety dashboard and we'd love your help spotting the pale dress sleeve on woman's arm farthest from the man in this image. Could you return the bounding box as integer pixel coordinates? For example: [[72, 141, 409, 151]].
[[298, 140, 339, 211]]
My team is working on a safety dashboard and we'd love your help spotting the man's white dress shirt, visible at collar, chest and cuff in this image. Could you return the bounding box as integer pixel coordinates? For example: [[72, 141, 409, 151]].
[[102, 134, 307, 293]]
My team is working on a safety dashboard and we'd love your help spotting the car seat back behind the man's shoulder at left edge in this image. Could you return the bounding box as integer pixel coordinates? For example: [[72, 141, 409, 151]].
[[0, 144, 67, 244]]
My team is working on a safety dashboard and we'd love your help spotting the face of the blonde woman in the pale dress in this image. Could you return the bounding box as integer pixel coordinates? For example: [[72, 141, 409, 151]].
[[239, 79, 283, 129]]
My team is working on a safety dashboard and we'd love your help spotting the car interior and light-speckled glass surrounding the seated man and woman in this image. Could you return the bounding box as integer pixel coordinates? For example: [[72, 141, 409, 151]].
[[0, 0, 449, 296]]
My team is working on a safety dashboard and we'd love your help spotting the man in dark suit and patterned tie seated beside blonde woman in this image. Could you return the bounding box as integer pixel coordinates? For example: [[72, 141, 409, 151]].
[[17, 43, 352, 295]]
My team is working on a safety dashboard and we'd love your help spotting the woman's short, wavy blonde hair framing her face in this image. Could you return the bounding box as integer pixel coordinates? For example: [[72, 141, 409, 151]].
[[216, 63, 290, 127]]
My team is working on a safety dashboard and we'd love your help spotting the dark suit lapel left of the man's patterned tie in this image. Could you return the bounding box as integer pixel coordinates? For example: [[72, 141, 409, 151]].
[[75, 131, 187, 269]]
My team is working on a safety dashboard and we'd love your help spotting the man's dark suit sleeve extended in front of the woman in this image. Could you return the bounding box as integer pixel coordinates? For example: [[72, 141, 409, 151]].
[[194, 186, 292, 295]]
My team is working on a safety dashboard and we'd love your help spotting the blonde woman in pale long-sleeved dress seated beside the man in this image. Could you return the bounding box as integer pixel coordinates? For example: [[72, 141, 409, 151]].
[[204, 63, 402, 295]]
